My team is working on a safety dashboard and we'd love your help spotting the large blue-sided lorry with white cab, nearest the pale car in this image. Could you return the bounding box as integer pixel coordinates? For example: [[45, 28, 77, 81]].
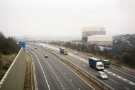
[[88, 57, 104, 71]]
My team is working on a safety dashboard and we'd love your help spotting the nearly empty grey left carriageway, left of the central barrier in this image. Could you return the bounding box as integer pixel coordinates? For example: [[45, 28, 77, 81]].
[[27, 45, 93, 90]]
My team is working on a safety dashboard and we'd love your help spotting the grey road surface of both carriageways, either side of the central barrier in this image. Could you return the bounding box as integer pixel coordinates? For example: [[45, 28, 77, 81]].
[[26, 44, 135, 90]]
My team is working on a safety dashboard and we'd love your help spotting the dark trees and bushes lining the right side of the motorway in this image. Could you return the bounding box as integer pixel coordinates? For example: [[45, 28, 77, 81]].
[[51, 34, 135, 68]]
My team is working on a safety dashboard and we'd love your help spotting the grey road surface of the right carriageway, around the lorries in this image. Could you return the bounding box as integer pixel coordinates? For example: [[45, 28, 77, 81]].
[[36, 43, 135, 90]]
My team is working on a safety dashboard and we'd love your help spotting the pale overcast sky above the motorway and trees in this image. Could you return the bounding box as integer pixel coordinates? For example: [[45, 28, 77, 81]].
[[0, 0, 135, 39]]
